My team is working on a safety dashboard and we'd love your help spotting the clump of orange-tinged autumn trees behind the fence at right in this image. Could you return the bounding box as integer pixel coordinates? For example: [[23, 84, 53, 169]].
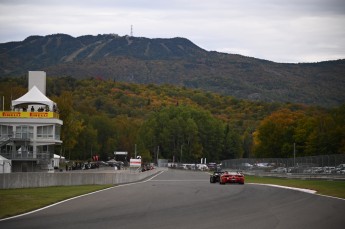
[[254, 106, 345, 158]]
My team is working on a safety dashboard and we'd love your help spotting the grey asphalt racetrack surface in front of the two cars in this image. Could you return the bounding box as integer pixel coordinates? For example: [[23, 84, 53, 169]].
[[0, 170, 345, 229]]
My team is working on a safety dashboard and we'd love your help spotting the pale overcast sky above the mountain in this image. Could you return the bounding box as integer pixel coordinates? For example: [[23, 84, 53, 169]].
[[0, 0, 345, 63]]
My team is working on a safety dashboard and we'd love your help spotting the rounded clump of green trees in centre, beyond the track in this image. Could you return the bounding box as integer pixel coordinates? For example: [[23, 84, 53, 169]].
[[139, 106, 224, 162]]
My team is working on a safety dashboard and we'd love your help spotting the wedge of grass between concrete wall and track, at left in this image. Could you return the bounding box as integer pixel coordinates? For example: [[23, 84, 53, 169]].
[[0, 185, 112, 219]]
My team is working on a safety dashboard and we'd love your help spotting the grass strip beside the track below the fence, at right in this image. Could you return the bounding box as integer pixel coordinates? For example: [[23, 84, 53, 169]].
[[246, 175, 345, 199]]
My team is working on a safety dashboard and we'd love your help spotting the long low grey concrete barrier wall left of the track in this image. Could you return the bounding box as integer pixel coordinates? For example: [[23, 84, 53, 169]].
[[0, 169, 160, 189]]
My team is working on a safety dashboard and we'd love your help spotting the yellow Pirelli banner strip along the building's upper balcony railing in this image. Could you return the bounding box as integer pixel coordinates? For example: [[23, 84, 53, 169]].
[[0, 111, 59, 119]]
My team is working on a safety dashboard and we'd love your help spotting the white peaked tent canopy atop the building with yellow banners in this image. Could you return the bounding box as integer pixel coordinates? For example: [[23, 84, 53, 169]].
[[12, 86, 56, 110]]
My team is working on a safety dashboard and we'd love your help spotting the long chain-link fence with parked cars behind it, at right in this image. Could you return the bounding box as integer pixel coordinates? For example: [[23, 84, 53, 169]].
[[222, 154, 345, 175]]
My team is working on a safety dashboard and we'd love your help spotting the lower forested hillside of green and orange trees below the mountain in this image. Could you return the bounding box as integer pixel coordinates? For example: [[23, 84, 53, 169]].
[[0, 77, 345, 162]]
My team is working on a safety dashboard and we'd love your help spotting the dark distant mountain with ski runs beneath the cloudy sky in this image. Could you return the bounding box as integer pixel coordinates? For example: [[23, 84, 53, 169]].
[[0, 34, 345, 107]]
